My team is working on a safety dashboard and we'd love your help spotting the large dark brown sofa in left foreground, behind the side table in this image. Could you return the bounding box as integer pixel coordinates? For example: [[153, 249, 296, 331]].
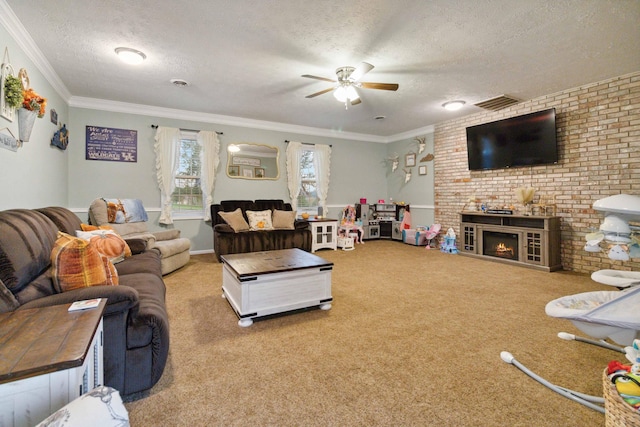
[[0, 207, 169, 395]]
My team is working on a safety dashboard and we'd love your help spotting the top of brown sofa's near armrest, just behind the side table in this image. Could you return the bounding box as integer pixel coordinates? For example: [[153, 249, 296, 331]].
[[18, 286, 138, 315]]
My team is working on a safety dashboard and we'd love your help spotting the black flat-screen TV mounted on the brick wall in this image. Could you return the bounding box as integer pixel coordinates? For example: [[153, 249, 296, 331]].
[[467, 108, 558, 170]]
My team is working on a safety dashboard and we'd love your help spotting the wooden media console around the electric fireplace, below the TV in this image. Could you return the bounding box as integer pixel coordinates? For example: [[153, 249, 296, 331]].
[[459, 212, 562, 271]]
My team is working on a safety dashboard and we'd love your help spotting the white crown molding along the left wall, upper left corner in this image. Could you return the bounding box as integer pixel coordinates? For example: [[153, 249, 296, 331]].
[[0, 0, 71, 103]]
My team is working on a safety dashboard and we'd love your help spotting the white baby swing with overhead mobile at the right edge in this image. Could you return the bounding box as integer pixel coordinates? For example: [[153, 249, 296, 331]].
[[500, 194, 640, 413]]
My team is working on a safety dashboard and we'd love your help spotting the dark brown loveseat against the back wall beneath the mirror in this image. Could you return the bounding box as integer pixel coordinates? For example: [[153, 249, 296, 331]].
[[211, 199, 311, 261]]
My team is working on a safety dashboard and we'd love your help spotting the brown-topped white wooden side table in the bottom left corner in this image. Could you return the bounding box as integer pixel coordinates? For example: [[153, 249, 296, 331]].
[[0, 298, 106, 426]]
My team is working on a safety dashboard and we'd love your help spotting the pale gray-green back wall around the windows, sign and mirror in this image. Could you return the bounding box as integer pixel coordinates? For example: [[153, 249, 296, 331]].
[[67, 108, 404, 252]]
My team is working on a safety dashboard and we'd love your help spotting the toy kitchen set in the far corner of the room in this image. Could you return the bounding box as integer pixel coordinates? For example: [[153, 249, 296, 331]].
[[356, 199, 409, 241]]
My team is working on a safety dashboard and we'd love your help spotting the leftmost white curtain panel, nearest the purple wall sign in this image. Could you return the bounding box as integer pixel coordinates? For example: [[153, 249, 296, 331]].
[[153, 127, 180, 224]]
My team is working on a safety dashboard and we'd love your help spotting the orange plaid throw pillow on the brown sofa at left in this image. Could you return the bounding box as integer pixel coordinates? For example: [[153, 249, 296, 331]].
[[51, 231, 118, 292]]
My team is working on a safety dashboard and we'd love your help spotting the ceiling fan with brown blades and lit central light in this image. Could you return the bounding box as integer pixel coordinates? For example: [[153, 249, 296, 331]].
[[302, 62, 399, 108]]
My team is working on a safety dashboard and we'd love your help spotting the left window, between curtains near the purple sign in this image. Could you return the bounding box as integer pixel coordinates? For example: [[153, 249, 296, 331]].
[[171, 132, 204, 218]]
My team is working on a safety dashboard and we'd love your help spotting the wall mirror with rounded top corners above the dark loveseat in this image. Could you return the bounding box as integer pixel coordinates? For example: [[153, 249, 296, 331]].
[[227, 143, 280, 179]]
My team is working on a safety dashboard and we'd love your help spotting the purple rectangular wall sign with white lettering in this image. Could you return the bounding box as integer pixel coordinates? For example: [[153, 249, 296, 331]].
[[85, 126, 138, 163]]
